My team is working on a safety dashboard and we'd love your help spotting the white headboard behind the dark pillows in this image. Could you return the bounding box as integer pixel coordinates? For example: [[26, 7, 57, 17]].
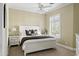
[[19, 26, 41, 36]]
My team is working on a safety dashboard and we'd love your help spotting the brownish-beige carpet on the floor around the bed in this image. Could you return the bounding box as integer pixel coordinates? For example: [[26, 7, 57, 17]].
[[9, 46, 75, 56]]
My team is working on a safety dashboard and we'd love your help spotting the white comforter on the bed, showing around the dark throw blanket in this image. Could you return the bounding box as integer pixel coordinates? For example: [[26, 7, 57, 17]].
[[20, 35, 56, 50]]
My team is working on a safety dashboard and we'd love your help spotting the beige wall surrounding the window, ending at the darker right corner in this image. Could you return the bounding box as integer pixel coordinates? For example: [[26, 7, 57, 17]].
[[46, 4, 73, 48]]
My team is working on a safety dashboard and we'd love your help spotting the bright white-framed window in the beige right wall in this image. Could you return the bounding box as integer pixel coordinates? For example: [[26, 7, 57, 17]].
[[49, 14, 61, 37]]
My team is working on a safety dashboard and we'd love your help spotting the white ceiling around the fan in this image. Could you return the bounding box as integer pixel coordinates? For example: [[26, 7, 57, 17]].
[[7, 3, 68, 14]]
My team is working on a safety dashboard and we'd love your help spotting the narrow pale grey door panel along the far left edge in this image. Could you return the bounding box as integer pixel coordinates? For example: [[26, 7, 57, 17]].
[[0, 3, 4, 56]]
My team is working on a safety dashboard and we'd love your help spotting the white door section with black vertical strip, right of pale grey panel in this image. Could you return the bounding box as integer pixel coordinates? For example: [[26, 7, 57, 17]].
[[2, 4, 8, 56]]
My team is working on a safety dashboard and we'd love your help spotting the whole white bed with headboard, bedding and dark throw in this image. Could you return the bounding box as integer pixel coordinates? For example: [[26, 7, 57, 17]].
[[20, 26, 56, 55]]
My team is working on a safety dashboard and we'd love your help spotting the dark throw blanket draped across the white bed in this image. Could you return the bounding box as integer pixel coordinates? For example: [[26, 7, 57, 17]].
[[20, 36, 54, 46]]
